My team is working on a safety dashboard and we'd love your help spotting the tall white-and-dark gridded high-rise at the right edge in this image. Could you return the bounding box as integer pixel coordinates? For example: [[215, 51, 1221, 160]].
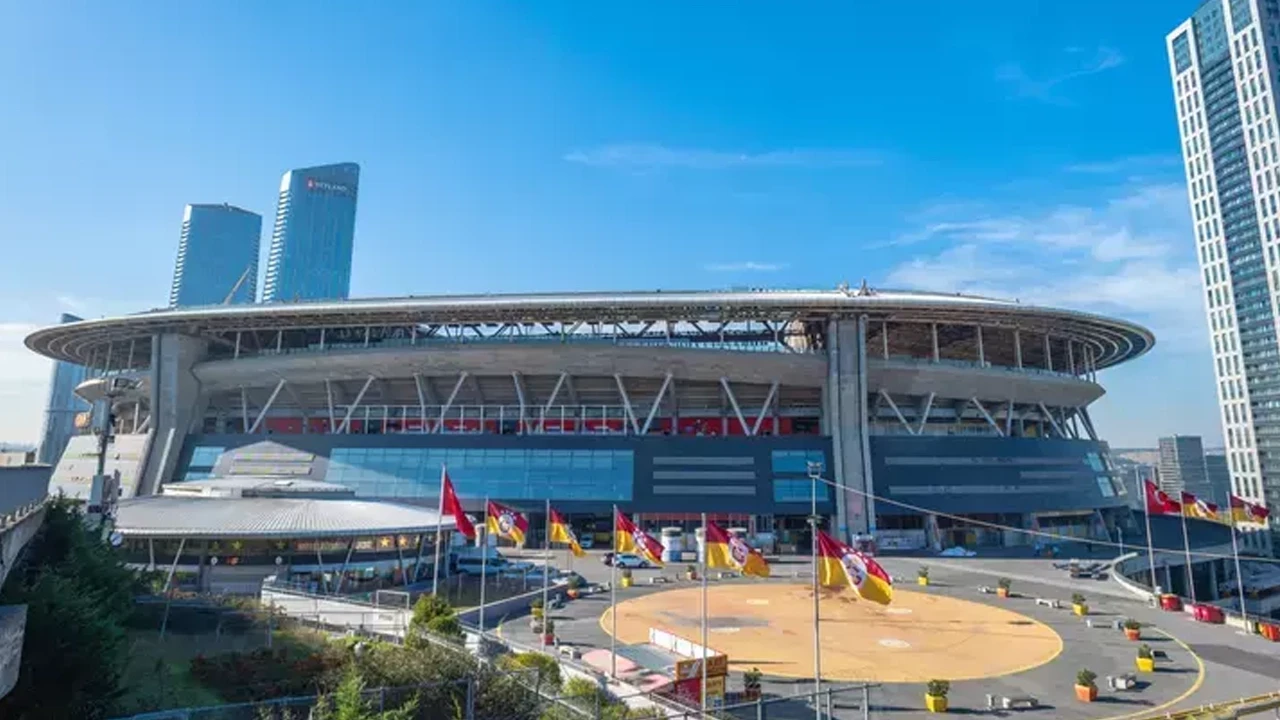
[[1166, 0, 1280, 543]]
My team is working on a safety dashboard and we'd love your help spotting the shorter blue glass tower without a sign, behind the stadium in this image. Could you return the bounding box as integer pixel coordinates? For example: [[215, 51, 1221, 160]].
[[169, 204, 262, 307]]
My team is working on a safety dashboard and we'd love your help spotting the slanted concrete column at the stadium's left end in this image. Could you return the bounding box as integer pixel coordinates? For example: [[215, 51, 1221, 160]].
[[138, 334, 209, 495]]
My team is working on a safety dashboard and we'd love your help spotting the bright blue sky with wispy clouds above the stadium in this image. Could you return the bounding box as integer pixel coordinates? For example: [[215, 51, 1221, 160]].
[[0, 0, 1221, 446]]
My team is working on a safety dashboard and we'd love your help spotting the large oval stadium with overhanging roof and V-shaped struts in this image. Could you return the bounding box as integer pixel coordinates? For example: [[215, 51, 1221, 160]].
[[26, 284, 1155, 550]]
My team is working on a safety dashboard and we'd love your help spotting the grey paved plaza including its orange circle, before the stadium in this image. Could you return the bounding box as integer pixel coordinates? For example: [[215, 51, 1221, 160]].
[[502, 548, 1280, 720]]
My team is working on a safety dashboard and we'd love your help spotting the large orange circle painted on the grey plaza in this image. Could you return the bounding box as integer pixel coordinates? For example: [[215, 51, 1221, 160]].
[[600, 583, 1062, 683]]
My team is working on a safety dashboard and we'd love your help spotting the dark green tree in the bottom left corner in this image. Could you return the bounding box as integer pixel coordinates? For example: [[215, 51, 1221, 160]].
[[0, 498, 145, 720]]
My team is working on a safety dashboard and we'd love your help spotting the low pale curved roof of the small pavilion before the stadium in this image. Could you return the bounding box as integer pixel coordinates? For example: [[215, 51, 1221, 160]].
[[115, 495, 454, 539]]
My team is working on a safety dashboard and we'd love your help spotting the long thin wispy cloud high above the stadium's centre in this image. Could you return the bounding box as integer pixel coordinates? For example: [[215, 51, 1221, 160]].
[[564, 143, 883, 170]]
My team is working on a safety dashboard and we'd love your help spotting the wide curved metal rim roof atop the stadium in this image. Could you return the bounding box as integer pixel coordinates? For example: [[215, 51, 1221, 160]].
[[26, 286, 1155, 368]]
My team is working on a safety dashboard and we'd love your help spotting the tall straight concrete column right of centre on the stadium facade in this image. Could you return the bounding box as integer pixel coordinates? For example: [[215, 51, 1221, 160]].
[[823, 315, 876, 539]]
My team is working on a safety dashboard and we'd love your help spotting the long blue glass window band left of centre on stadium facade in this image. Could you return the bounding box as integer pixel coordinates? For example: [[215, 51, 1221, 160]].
[[325, 447, 635, 502]]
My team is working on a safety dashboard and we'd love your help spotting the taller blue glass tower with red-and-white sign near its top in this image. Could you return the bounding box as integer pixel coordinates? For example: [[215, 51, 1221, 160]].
[[262, 163, 360, 302]]
